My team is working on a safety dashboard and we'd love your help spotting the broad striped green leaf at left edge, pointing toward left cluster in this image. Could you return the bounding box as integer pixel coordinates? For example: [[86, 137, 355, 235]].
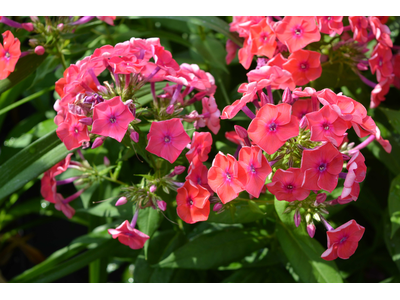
[[0, 131, 68, 199]]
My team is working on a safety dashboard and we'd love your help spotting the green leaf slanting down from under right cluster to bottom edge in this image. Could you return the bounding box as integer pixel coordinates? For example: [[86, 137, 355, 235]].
[[275, 200, 343, 282]]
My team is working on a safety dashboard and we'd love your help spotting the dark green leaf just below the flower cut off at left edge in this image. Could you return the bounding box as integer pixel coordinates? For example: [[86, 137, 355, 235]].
[[0, 54, 47, 94]]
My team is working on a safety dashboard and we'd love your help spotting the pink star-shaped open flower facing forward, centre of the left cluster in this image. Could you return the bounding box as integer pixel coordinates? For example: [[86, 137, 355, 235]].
[[91, 96, 135, 142]]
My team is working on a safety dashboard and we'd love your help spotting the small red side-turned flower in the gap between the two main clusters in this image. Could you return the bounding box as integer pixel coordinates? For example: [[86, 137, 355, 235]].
[[186, 131, 212, 163]]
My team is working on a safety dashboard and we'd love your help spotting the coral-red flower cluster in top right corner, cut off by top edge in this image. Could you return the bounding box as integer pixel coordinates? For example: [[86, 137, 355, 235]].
[[226, 16, 400, 108]]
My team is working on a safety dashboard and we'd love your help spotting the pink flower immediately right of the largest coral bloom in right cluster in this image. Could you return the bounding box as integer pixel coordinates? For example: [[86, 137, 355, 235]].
[[306, 105, 347, 147]]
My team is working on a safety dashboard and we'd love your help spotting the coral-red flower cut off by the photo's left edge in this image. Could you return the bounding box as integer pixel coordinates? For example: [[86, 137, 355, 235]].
[[0, 30, 21, 80]]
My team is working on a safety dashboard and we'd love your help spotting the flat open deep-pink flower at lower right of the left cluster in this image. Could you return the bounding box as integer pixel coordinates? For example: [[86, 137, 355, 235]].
[[146, 118, 190, 164]]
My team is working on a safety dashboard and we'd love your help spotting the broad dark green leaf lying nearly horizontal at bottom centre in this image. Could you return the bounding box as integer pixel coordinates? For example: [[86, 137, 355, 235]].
[[156, 229, 266, 270]]
